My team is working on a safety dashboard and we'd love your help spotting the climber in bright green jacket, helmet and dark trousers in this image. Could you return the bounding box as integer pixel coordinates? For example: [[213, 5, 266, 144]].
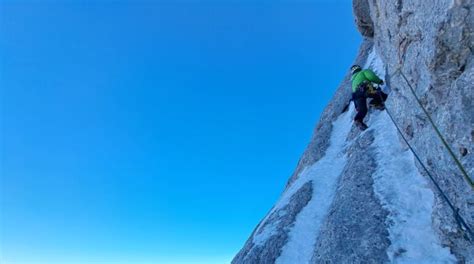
[[351, 65, 388, 130]]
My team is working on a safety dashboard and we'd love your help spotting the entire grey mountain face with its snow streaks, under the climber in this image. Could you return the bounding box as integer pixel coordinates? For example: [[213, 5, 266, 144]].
[[232, 0, 474, 263]]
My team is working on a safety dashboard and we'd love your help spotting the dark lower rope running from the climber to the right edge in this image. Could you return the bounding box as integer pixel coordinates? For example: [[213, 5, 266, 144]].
[[377, 93, 474, 243]]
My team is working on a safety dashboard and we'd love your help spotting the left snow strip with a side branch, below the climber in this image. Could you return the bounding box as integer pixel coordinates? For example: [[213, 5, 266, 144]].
[[275, 106, 354, 264]]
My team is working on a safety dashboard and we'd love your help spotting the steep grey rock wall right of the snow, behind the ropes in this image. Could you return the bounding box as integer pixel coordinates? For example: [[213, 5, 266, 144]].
[[370, 0, 474, 261]]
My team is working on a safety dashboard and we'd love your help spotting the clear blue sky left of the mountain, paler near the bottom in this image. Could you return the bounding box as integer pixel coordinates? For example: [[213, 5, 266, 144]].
[[0, 0, 361, 264]]
